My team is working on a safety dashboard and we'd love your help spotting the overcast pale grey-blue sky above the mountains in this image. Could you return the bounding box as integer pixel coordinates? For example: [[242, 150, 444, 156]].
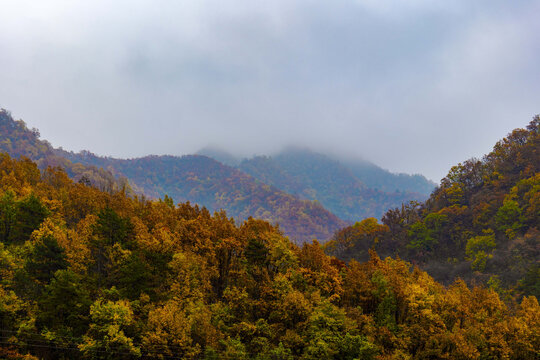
[[0, 0, 540, 181]]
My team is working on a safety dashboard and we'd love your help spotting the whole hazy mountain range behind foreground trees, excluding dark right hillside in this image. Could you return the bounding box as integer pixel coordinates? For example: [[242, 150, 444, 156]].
[[0, 106, 427, 242]]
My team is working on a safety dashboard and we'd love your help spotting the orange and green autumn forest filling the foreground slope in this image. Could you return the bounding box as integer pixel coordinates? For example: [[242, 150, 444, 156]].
[[0, 153, 540, 360]]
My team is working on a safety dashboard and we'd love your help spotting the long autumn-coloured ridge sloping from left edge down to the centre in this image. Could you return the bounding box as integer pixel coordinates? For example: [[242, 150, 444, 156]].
[[0, 110, 346, 242]]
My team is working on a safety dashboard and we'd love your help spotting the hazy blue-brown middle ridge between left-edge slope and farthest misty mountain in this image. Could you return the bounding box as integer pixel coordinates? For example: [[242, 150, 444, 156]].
[[56, 151, 345, 242]]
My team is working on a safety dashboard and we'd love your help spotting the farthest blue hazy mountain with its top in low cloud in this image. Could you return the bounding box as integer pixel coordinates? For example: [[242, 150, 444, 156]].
[[239, 148, 431, 221]]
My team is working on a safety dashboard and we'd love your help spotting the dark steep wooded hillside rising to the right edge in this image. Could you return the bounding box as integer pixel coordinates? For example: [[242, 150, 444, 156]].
[[327, 116, 540, 297]]
